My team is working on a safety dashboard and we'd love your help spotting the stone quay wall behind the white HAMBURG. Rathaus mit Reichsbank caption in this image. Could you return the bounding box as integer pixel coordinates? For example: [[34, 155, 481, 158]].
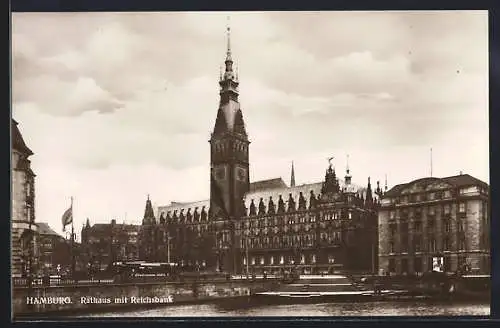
[[12, 281, 278, 318]]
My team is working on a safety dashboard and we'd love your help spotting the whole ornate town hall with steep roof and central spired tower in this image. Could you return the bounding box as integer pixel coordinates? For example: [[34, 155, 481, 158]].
[[140, 29, 387, 274]]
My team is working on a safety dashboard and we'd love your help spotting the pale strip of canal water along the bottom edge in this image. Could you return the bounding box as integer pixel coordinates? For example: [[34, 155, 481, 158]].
[[81, 302, 490, 318]]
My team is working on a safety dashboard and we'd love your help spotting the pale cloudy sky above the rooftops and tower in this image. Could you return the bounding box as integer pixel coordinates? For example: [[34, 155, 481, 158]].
[[11, 11, 489, 236]]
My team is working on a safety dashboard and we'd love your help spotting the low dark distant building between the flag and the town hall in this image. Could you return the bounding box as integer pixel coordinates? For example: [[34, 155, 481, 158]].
[[81, 219, 140, 270]]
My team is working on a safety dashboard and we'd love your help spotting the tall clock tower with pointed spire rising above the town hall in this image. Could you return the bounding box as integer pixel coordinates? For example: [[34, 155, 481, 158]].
[[209, 22, 250, 219]]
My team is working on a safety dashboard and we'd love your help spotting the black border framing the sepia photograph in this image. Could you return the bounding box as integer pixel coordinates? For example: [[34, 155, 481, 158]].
[[7, 0, 500, 327]]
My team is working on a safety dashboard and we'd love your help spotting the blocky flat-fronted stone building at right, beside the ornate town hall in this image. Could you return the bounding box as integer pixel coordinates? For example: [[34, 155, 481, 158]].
[[378, 174, 490, 275]]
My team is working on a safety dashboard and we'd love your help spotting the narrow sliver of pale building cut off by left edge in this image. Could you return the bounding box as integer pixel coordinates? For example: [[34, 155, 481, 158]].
[[11, 119, 37, 277]]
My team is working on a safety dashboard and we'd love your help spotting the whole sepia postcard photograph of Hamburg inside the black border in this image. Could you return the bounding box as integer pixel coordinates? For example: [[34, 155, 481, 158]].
[[10, 10, 491, 320]]
